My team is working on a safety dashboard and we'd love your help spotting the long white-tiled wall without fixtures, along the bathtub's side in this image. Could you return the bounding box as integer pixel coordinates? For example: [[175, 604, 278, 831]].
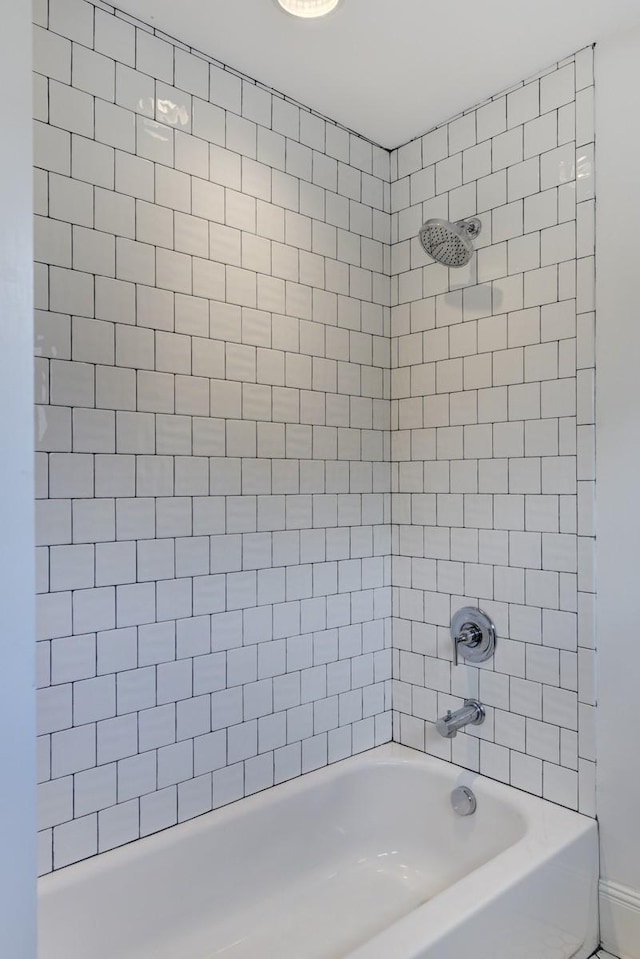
[[34, 0, 391, 872]]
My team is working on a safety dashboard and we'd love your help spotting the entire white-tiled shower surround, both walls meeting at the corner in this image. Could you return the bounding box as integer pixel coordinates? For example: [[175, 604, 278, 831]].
[[34, 0, 595, 873]]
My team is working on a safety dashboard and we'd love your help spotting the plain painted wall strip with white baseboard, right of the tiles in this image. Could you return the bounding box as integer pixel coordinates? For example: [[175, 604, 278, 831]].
[[596, 24, 640, 959]]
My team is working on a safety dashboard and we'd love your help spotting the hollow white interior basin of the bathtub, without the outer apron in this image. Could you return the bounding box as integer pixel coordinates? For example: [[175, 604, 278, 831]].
[[40, 750, 584, 959]]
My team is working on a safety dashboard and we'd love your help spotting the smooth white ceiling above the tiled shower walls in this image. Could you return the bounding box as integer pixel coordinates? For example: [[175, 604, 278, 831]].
[[117, 0, 640, 147]]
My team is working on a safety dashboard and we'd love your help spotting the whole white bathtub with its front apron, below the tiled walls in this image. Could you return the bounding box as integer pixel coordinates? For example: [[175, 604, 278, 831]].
[[39, 745, 598, 959]]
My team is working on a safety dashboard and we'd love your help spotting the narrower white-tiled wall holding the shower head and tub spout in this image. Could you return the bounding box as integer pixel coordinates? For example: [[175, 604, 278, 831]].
[[391, 48, 596, 815]]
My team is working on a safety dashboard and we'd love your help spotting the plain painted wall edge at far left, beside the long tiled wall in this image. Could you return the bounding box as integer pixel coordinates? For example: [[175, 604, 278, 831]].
[[0, 0, 36, 959]]
